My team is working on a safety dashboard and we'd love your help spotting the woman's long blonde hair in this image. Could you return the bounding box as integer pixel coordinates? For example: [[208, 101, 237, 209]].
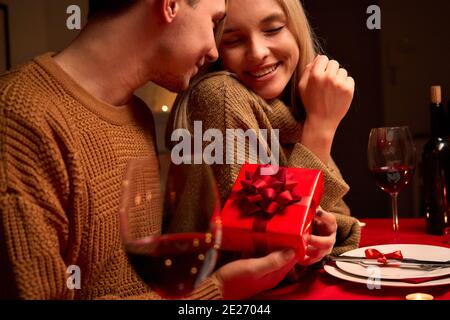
[[166, 0, 321, 144]]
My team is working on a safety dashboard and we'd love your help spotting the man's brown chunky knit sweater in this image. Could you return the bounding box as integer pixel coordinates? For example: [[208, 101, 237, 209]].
[[0, 54, 221, 299]]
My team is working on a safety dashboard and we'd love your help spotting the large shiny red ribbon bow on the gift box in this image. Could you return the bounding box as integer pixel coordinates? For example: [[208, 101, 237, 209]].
[[237, 166, 302, 217]]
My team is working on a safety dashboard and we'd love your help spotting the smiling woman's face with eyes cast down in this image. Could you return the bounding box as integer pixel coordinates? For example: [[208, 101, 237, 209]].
[[220, 0, 300, 100]]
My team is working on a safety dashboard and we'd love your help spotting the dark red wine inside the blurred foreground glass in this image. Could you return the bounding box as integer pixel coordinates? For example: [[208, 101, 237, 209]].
[[126, 233, 217, 298]]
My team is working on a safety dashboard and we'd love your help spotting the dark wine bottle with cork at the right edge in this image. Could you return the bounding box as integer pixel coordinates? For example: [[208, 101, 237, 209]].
[[422, 86, 450, 235]]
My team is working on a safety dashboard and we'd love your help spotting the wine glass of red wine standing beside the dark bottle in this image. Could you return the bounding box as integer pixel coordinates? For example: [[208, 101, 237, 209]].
[[367, 127, 416, 235]]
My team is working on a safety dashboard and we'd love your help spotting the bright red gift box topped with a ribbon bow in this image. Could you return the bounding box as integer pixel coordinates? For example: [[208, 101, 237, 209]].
[[221, 164, 323, 264]]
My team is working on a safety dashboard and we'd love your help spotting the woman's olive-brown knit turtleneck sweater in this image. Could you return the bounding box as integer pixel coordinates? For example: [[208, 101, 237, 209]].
[[188, 74, 360, 254]]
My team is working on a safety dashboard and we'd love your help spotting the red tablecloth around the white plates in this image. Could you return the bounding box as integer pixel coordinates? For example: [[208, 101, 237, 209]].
[[258, 219, 450, 300]]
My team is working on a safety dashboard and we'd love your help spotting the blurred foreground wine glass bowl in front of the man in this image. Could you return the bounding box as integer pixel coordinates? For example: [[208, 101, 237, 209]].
[[120, 159, 221, 298]]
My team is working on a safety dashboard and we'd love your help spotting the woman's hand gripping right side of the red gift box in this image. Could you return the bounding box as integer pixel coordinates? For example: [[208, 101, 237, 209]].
[[305, 208, 337, 265]]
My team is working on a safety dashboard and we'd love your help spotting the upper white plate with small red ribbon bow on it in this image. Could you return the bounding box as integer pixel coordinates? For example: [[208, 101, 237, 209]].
[[336, 244, 450, 280]]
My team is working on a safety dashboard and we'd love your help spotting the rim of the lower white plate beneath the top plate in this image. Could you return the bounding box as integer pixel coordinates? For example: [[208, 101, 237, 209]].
[[324, 265, 450, 289]]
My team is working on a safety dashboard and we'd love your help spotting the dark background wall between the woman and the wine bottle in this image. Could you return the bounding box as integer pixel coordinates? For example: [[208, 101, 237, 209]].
[[302, 0, 450, 217]]
